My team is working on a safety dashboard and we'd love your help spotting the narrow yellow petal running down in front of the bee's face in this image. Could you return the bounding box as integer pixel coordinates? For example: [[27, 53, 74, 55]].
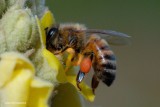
[[36, 11, 66, 82]]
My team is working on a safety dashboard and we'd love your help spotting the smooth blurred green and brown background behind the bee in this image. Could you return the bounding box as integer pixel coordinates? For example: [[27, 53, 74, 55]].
[[47, 0, 160, 107]]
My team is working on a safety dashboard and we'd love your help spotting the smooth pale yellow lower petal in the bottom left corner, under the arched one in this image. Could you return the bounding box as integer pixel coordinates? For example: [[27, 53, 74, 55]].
[[0, 70, 33, 107]]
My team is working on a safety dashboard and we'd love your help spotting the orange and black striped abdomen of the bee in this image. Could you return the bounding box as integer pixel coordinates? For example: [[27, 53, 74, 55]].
[[92, 37, 116, 86]]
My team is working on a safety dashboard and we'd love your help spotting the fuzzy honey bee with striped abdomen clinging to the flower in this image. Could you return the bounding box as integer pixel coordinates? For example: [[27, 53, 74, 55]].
[[46, 24, 129, 93]]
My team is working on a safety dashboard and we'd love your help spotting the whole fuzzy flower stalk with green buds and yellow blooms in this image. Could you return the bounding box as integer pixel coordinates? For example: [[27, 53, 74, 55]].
[[0, 0, 95, 107]]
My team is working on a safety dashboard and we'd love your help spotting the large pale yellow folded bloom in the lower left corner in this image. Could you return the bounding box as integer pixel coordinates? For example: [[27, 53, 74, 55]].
[[0, 52, 34, 107]]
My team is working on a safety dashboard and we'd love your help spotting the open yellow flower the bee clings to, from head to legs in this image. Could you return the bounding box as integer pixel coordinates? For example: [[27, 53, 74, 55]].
[[37, 11, 95, 101]]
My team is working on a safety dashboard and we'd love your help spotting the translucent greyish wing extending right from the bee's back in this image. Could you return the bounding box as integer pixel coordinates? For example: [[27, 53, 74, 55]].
[[85, 29, 130, 45]]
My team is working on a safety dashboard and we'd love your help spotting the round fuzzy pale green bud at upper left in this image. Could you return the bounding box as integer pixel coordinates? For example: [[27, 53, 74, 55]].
[[0, 6, 39, 52]]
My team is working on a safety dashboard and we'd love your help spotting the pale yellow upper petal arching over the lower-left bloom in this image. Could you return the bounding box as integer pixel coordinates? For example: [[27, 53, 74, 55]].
[[0, 52, 34, 87]]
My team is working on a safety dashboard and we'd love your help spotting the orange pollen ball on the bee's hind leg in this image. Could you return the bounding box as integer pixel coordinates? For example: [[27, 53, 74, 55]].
[[80, 57, 92, 73]]
